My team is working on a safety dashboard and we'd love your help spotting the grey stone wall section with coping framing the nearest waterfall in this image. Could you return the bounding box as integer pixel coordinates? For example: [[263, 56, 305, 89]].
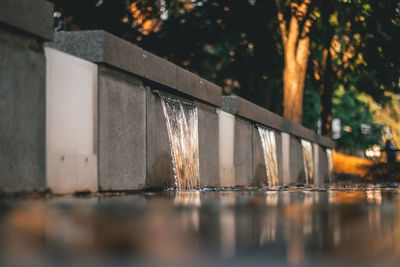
[[47, 31, 221, 191]]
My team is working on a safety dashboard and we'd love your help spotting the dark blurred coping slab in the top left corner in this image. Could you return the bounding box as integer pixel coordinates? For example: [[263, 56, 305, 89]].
[[0, 0, 54, 41]]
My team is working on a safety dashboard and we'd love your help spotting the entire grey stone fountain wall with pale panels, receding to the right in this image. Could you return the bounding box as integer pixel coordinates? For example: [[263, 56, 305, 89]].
[[0, 0, 334, 193]]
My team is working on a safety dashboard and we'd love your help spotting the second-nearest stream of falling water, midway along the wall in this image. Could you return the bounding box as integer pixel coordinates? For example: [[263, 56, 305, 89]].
[[257, 126, 278, 185]]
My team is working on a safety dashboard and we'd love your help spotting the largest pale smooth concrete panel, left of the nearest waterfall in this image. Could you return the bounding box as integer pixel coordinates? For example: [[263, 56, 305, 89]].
[[46, 48, 98, 193]]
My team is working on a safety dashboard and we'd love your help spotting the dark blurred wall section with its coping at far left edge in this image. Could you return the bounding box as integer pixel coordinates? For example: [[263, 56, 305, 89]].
[[0, 0, 53, 192]]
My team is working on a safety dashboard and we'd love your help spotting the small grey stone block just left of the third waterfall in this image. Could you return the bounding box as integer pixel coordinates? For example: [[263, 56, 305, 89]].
[[290, 136, 305, 184]]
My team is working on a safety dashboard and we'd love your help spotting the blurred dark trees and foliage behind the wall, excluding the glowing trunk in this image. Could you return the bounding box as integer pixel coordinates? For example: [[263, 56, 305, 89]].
[[51, 0, 400, 158]]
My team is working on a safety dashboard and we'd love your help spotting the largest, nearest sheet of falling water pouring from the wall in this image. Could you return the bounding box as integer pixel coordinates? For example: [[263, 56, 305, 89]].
[[160, 95, 200, 191]]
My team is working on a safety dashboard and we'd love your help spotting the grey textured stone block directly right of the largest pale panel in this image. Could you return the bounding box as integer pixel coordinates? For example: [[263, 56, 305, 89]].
[[99, 68, 147, 191]]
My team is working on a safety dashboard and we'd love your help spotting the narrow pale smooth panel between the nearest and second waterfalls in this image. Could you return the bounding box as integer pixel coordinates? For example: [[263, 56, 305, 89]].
[[217, 110, 235, 186]]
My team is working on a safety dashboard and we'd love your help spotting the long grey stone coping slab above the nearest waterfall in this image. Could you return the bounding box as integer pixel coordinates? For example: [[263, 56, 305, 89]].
[[48, 30, 222, 107]]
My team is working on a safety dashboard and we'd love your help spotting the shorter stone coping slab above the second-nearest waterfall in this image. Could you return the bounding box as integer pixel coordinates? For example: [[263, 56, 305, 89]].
[[221, 95, 285, 131]]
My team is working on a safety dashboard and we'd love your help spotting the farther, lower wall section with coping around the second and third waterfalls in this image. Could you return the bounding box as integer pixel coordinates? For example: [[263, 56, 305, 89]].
[[221, 95, 334, 185]]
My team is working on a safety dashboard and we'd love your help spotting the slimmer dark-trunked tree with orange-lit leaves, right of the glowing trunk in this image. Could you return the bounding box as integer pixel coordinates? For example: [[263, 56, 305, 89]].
[[311, 0, 400, 136]]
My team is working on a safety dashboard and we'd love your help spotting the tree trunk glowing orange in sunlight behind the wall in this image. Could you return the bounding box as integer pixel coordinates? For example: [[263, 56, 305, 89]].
[[275, 0, 314, 123]]
